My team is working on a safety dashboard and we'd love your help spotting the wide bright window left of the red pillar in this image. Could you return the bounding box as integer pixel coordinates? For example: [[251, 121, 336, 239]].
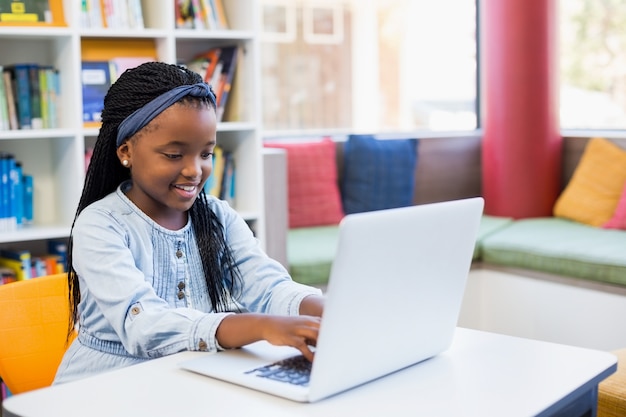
[[261, 0, 478, 132]]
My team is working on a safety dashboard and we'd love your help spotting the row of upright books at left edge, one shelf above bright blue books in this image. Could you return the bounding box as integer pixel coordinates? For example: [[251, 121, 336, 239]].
[[0, 63, 60, 130]]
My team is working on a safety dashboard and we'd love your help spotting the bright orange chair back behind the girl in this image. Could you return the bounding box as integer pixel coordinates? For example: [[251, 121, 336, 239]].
[[0, 274, 75, 394]]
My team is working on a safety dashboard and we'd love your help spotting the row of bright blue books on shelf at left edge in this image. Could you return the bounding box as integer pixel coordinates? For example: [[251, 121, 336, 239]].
[[0, 152, 33, 232]]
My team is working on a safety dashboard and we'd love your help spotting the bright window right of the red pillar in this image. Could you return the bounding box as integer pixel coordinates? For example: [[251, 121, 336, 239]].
[[560, 0, 626, 129]]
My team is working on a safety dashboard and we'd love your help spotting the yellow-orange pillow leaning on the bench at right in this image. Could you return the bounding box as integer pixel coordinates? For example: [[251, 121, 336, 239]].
[[553, 138, 626, 226]]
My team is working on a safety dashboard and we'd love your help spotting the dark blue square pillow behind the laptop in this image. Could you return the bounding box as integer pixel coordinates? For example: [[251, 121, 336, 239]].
[[341, 135, 417, 214]]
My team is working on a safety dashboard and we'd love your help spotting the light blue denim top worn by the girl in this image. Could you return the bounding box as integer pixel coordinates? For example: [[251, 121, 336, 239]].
[[55, 182, 321, 383]]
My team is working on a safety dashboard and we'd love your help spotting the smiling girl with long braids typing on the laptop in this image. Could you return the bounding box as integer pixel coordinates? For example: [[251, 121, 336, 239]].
[[55, 62, 323, 383]]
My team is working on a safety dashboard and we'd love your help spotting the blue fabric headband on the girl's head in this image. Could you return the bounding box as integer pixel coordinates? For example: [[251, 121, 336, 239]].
[[116, 83, 215, 147]]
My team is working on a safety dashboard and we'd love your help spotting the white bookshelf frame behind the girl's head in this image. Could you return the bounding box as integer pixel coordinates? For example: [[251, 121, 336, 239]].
[[0, 0, 264, 248]]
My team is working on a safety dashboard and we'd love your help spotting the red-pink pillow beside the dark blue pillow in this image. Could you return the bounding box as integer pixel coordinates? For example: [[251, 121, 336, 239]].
[[264, 138, 344, 228]]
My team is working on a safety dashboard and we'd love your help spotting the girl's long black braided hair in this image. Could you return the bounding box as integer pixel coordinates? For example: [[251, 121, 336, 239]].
[[67, 62, 240, 338]]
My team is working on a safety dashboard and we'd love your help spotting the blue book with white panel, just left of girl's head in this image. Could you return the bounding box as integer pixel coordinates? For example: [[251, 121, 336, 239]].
[[81, 61, 111, 122]]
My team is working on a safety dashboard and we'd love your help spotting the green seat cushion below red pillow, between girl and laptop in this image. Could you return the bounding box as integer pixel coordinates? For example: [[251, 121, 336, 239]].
[[287, 226, 339, 285]]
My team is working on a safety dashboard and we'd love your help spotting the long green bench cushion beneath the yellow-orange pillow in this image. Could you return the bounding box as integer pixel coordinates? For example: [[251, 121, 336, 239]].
[[481, 217, 626, 285]]
